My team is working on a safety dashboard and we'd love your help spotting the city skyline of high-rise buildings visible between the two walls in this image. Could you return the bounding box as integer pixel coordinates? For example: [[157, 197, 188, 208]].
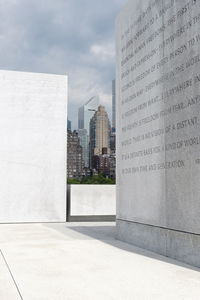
[[67, 102, 116, 179]]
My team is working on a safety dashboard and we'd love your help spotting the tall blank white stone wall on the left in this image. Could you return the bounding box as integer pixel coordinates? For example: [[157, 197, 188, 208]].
[[0, 71, 67, 223]]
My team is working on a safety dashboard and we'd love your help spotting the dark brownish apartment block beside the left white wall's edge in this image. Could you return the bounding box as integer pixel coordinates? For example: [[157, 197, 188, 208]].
[[67, 130, 84, 178]]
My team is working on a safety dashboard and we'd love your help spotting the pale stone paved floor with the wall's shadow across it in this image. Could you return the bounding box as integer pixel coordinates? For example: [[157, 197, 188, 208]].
[[0, 223, 200, 300]]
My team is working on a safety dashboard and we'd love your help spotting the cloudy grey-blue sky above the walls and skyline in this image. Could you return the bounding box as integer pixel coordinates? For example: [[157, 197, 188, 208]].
[[0, 0, 127, 128]]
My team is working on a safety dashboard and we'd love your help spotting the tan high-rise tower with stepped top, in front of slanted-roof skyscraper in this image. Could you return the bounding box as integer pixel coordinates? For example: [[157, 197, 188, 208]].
[[90, 105, 110, 168]]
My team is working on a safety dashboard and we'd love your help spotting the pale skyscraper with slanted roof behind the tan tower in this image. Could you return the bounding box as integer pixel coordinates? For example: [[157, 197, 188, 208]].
[[78, 96, 99, 135]]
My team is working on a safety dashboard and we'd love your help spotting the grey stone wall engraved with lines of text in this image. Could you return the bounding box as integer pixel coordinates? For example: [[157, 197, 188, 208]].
[[116, 0, 200, 266]]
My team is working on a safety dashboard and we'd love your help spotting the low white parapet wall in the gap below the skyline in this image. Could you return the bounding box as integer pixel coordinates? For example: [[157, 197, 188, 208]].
[[71, 184, 116, 216]]
